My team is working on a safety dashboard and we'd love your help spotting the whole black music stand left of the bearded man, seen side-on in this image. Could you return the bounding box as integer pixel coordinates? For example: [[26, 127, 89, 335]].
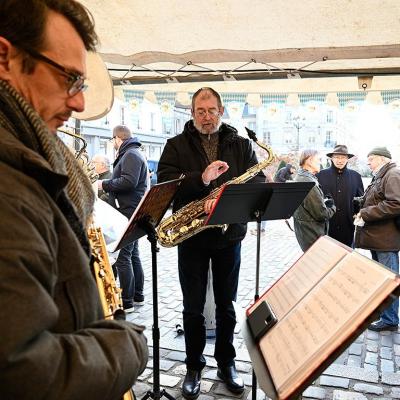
[[114, 177, 183, 400]]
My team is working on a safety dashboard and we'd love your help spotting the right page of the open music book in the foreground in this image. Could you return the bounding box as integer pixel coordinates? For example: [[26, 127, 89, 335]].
[[259, 252, 399, 399]]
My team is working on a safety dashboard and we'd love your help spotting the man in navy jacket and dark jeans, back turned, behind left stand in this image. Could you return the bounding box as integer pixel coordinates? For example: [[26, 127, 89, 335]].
[[98, 125, 148, 312]]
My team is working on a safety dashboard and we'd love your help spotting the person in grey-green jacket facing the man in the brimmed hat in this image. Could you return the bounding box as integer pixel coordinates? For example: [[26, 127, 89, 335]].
[[293, 149, 336, 251]]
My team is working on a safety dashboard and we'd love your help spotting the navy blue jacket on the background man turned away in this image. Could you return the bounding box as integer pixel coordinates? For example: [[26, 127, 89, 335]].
[[103, 138, 148, 218]]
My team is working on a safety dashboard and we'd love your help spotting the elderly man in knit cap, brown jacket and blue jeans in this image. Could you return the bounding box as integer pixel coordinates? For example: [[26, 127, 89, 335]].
[[354, 147, 400, 332]]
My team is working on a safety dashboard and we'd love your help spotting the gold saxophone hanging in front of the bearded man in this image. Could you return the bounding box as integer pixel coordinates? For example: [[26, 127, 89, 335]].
[[157, 128, 275, 247]]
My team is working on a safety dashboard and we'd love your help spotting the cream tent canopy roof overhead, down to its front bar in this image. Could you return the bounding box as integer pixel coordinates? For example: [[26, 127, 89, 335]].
[[82, 0, 400, 83]]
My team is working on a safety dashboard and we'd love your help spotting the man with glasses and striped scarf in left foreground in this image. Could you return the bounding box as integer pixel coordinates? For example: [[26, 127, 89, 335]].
[[0, 0, 148, 400]]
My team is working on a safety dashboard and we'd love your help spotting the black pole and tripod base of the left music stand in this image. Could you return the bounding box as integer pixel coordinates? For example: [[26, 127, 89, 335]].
[[140, 220, 175, 400]]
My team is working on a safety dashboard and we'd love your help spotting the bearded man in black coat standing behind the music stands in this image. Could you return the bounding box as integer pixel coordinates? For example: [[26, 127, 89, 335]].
[[157, 88, 265, 399]]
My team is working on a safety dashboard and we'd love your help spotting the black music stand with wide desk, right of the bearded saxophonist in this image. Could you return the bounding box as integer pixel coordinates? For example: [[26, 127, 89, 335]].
[[206, 182, 314, 400]]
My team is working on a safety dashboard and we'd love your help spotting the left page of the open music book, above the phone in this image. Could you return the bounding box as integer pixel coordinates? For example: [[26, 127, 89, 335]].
[[261, 236, 350, 321]]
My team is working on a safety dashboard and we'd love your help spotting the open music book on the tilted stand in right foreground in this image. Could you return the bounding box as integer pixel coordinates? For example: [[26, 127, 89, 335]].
[[243, 236, 400, 400]]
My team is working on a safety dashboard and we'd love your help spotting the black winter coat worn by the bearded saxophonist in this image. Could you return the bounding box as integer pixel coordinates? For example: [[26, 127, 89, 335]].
[[157, 120, 265, 248]]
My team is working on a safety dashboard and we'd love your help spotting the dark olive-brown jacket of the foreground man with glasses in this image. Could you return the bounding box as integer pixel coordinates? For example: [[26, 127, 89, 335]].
[[0, 128, 148, 400]]
